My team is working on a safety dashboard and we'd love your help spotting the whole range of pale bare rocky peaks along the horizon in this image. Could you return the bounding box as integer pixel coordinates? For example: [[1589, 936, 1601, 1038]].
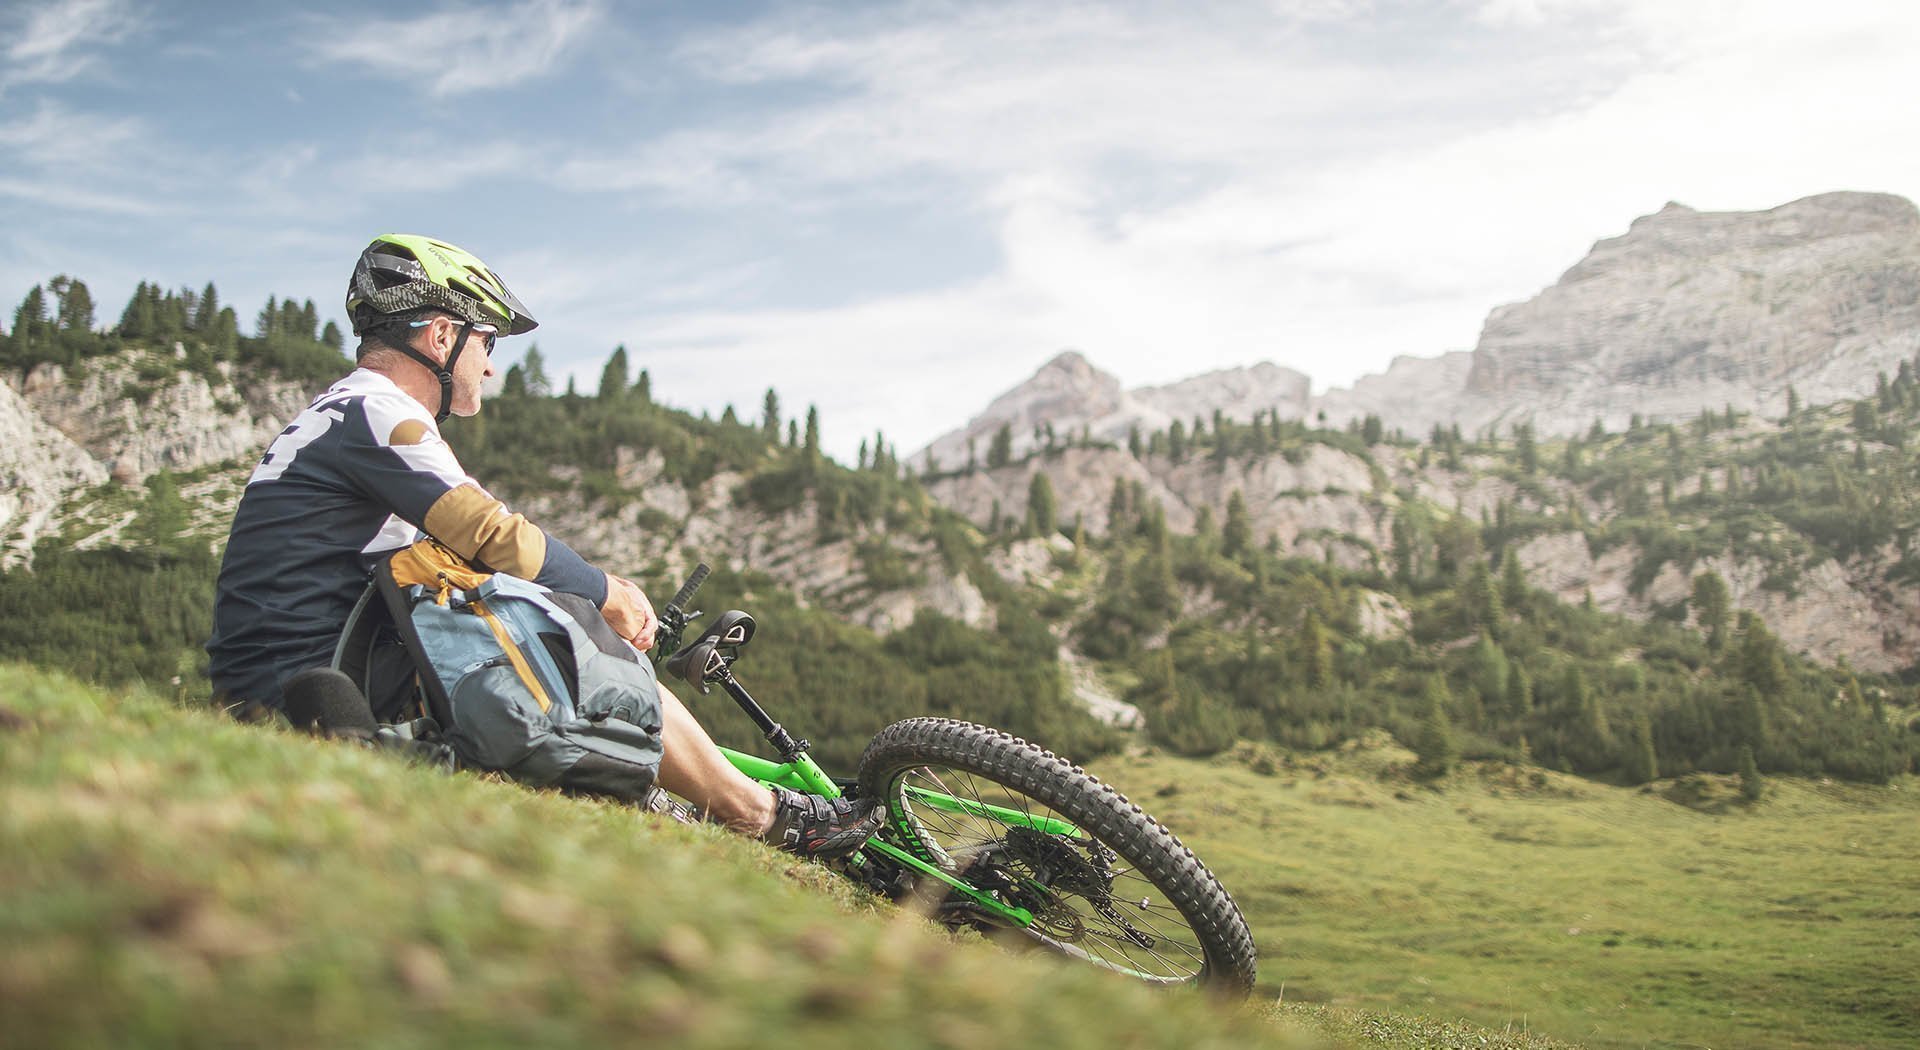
[[910, 192, 1920, 468]]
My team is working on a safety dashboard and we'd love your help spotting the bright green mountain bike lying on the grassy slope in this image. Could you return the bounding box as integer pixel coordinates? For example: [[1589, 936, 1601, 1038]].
[[655, 564, 1256, 998]]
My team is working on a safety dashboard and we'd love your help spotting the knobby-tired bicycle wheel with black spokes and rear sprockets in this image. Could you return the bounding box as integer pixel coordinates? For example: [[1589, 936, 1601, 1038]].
[[860, 718, 1256, 996]]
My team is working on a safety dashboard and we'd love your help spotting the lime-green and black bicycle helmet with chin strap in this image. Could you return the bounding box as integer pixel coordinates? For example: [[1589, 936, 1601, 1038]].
[[348, 234, 540, 422]]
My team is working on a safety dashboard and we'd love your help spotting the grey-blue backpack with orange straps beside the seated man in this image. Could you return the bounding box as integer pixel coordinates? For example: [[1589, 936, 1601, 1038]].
[[334, 539, 660, 802]]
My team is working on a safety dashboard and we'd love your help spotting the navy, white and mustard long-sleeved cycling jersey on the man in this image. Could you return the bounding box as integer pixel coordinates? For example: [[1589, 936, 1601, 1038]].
[[207, 369, 607, 706]]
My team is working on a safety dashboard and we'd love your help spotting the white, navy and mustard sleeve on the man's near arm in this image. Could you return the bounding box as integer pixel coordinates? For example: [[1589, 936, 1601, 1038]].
[[344, 397, 607, 605]]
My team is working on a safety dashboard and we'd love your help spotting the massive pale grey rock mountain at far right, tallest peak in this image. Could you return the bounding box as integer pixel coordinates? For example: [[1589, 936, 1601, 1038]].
[[1461, 194, 1920, 432]]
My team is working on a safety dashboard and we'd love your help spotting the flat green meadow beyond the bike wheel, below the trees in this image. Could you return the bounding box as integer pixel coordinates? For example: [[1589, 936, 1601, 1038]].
[[1096, 747, 1920, 1048]]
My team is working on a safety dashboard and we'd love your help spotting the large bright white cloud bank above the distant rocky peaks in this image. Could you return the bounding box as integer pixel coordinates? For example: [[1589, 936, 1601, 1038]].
[[533, 0, 1920, 458]]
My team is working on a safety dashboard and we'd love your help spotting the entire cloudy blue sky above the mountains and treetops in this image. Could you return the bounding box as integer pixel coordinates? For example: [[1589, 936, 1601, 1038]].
[[0, 0, 1920, 455]]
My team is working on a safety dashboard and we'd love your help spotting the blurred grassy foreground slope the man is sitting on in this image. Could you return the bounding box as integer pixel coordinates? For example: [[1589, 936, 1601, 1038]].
[[0, 666, 1589, 1048]]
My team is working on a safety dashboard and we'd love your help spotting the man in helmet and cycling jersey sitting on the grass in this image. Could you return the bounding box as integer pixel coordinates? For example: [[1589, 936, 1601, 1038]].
[[207, 234, 879, 856]]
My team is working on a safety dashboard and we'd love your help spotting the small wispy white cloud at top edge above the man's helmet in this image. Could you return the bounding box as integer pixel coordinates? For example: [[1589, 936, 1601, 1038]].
[[311, 0, 601, 96]]
